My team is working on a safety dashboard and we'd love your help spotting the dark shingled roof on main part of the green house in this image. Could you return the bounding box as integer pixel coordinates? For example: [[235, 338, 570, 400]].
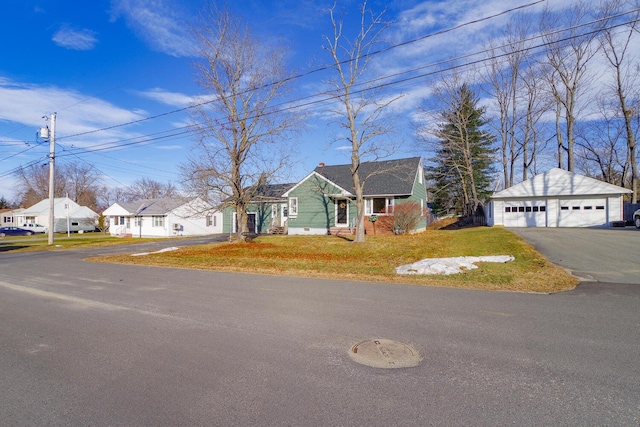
[[314, 157, 420, 196]]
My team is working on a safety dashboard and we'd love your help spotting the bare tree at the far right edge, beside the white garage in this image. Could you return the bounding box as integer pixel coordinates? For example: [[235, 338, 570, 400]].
[[600, 0, 640, 203]]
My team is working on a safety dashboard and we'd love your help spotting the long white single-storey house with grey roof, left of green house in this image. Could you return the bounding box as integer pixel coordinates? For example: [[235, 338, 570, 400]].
[[103, 197, 222, 237]]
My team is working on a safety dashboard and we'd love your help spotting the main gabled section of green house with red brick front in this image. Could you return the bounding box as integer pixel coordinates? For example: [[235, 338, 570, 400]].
[[283, 157, 428, 234]]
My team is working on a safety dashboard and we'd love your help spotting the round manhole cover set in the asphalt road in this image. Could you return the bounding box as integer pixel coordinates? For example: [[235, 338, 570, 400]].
[[349, 338, 422, 369]]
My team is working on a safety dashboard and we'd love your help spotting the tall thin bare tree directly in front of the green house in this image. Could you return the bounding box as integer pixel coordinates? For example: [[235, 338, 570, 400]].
[[324, 0, 397, 243]]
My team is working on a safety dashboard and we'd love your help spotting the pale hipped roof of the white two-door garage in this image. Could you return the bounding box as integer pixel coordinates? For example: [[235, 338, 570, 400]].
[[491, 168, 632, 199]]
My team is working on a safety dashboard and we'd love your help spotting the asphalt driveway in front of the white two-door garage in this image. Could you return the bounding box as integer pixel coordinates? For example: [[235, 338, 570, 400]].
[[509, 227, 640, 284]]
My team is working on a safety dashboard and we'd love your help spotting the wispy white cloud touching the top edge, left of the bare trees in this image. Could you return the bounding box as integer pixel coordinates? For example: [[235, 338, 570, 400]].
[[111, 0, 195, 57]]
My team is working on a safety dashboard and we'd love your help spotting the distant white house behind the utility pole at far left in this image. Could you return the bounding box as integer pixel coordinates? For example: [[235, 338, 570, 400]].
[[13, 197, 98, 233]]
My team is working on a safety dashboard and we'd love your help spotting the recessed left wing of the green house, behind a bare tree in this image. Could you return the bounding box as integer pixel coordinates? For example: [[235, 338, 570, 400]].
[[222, 183, 295, 234]]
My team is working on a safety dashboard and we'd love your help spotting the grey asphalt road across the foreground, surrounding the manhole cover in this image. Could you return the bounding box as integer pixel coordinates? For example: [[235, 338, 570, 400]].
[[0, 241, 640, 426]]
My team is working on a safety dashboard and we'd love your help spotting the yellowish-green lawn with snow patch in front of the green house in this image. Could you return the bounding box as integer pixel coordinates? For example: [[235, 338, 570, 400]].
[[91, 227, 578, 292]]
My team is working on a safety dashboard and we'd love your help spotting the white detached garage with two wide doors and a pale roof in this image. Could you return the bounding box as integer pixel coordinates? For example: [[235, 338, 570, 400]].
[[486, 168, 631, 227]]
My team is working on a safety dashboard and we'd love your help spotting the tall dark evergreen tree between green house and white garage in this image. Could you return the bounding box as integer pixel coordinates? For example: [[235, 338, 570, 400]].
[[430, 83, 495, 216]]
